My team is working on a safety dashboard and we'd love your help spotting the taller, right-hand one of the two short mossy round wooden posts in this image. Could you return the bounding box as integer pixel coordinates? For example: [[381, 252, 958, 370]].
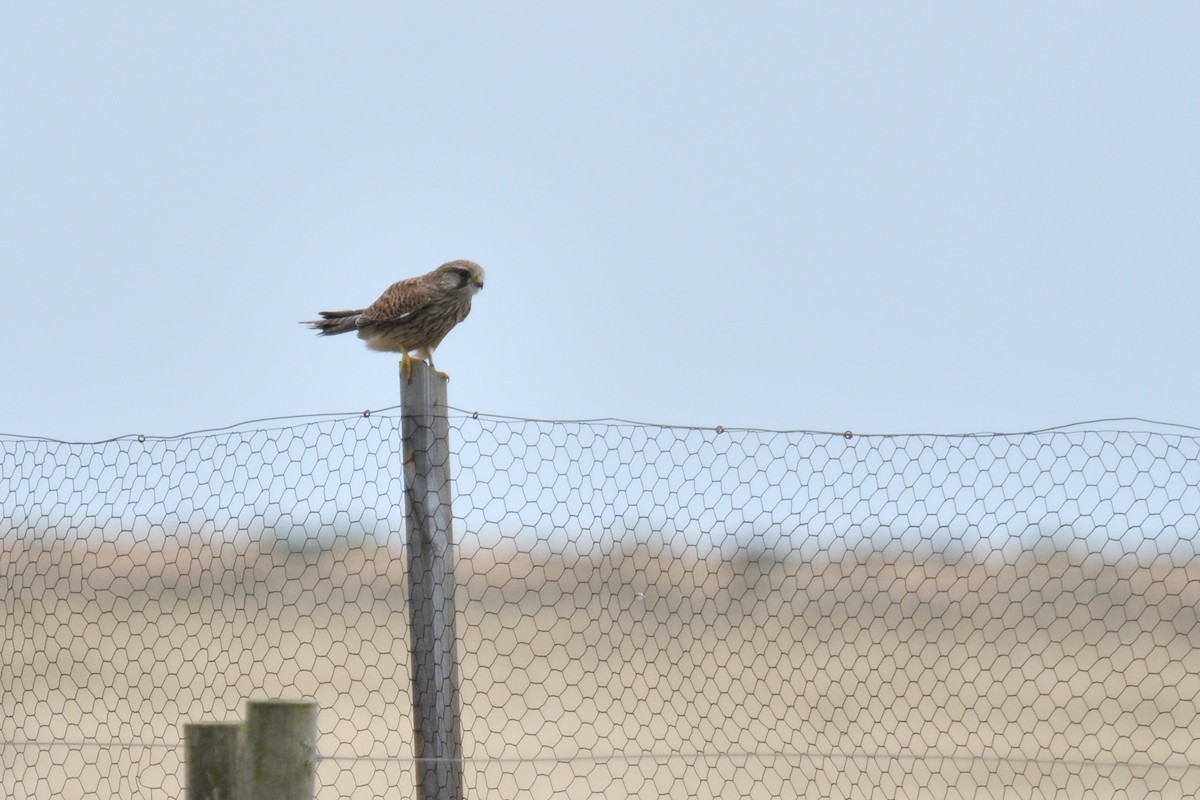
[[239, 700, 317, 800]]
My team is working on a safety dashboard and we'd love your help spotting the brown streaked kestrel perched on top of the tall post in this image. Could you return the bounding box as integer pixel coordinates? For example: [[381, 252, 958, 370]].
[[302, 260, 484, 378]]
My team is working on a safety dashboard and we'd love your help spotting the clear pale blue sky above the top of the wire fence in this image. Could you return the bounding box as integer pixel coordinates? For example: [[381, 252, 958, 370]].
[[0, 2, 1200, 439]]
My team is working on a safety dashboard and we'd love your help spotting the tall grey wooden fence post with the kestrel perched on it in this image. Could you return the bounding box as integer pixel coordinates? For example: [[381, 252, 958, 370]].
[[400, 360, 463, 800]]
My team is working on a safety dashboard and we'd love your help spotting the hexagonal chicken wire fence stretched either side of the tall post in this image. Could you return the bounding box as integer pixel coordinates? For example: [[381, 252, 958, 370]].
[[0, 409, 1200, 799]]
